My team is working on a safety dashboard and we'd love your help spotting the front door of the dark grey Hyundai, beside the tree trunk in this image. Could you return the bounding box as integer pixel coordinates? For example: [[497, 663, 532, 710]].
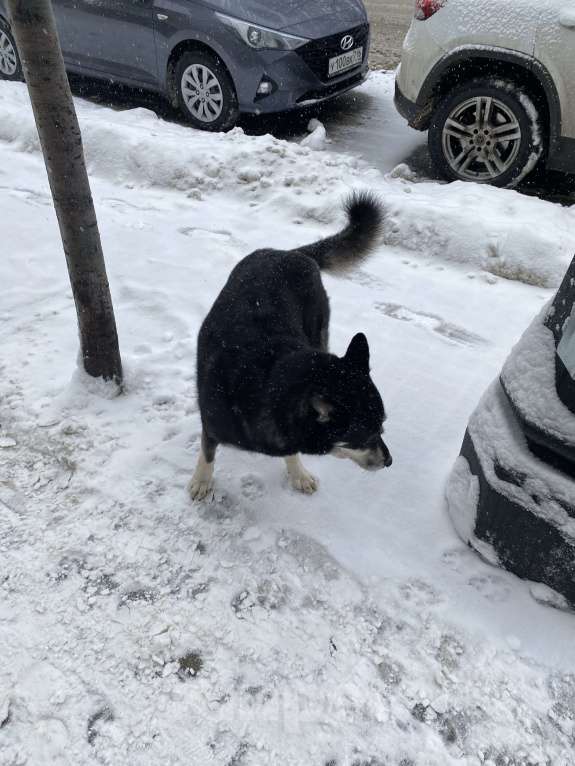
[[54, 0, 158, 85]]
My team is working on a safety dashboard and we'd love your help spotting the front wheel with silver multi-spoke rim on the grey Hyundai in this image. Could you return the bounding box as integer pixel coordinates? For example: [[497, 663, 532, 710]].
[[174, 50, 239, 131]]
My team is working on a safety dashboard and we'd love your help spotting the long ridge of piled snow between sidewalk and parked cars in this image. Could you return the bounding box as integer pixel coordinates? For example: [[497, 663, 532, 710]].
[[0, 76, 575, 287]]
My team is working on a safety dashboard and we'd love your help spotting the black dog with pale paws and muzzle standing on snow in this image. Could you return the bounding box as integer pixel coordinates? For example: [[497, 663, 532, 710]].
[[190, 193, 391, 500]]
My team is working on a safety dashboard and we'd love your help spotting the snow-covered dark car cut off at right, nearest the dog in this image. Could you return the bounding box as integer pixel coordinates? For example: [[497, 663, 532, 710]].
[[447, 259, 575, 608]]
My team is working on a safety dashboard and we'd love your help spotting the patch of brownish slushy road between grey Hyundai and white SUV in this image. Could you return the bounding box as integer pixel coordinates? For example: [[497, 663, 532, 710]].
[[364, 0, 415, 69]]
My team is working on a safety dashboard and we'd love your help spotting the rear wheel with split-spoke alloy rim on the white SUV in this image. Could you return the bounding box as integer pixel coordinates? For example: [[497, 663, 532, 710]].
[[428, 79, 544, 187]]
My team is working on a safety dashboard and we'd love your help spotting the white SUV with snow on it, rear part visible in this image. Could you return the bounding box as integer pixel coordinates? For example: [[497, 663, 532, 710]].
[[395, 0, 575, 186]]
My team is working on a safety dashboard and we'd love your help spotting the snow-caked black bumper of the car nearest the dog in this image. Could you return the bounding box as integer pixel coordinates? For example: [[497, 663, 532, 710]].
[[446, 382, 575, 608]]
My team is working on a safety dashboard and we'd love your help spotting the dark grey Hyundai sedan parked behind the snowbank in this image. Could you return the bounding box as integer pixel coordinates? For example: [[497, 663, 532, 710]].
[[0, 0, 369, 130]]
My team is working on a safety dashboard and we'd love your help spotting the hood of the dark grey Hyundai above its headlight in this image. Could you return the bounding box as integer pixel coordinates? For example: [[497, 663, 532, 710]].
[[210, 0, 367, 38]]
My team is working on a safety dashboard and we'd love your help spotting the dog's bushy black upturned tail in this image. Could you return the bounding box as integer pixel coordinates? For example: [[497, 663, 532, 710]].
[[297, 191, 383, 272]]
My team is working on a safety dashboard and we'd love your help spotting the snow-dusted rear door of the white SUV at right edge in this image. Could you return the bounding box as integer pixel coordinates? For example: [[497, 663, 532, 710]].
[[535, 0, 575, 139]]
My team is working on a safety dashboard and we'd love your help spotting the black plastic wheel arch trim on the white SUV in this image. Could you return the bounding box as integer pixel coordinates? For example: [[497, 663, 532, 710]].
[[417, 46, 561, 160]]
